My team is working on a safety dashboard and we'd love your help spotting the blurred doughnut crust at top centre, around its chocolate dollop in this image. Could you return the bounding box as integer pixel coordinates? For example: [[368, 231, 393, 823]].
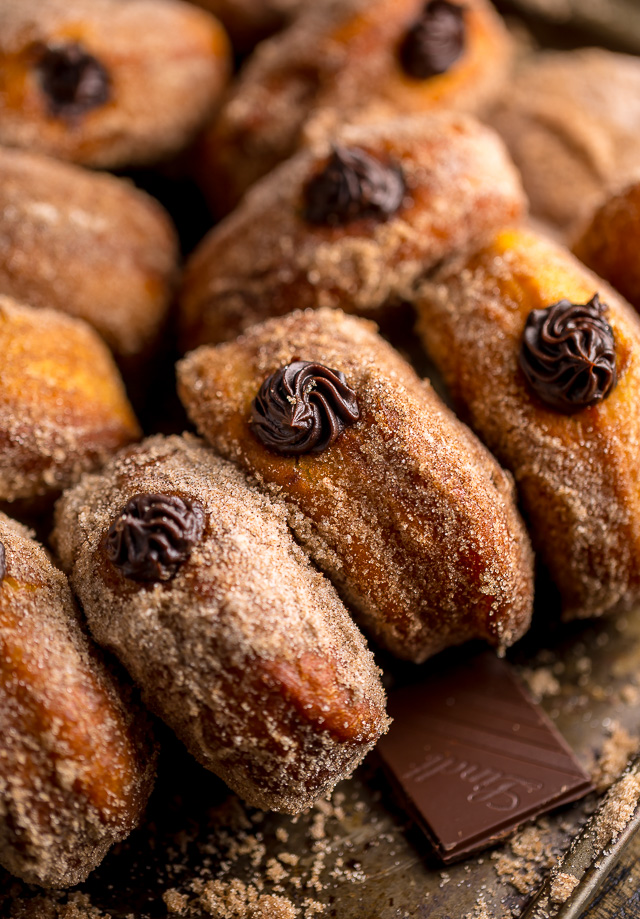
[[200, 0, 510, 212]]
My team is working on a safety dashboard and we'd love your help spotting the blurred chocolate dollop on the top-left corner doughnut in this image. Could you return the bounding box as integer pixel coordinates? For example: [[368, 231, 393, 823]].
[[37, 43, 111, 117]]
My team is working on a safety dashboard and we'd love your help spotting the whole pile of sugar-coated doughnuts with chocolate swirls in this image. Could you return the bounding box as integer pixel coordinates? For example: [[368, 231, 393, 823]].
[[0, 0, 640, 900]]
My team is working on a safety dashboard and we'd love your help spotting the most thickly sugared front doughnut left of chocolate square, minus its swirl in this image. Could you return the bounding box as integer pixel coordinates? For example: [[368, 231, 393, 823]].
[[55, 436, 388, 813]]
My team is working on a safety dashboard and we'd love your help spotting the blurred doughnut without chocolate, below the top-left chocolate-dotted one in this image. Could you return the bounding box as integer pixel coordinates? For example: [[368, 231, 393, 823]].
[[0, 149, 178, 358]]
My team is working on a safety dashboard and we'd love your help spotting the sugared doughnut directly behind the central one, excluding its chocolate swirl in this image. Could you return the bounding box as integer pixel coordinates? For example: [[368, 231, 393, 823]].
[[180, 113, 525, 349]]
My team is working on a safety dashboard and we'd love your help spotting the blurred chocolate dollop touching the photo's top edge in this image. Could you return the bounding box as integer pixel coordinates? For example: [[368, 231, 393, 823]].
[[400, 0, 466, 80]]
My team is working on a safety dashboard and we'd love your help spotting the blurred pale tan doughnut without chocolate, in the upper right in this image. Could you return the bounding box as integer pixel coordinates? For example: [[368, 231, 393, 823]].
[[490, 48, 640, 229]]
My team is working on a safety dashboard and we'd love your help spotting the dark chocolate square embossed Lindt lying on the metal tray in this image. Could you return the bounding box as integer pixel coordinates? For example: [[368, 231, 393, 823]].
[[378, 654, 593, 864]]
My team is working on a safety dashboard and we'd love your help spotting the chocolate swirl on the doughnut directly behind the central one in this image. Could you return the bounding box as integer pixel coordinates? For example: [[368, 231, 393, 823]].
[[304, 147, 406, 226]]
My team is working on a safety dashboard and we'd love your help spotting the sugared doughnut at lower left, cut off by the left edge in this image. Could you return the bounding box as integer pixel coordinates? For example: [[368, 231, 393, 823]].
[[0, 514, 155, 887]]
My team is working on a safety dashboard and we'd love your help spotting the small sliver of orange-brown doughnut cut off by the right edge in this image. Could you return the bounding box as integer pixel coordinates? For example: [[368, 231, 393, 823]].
[[573, 182, 640, 310]]
